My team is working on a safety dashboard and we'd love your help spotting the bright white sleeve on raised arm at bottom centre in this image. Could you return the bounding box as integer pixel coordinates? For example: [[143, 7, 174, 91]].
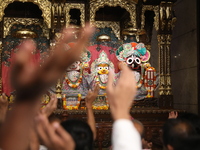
[[112, 119, 142, 150]]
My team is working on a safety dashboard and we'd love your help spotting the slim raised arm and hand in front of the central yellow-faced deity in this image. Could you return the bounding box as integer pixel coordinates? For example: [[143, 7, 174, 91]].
[[85, 85, 99, 140]]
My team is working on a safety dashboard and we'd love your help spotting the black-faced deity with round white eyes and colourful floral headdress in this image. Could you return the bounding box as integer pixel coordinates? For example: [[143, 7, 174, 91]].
[[116, 42, 158, 100]]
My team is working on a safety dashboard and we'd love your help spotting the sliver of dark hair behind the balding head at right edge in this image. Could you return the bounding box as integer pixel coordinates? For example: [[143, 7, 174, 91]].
[[178, 113, 200, 135]]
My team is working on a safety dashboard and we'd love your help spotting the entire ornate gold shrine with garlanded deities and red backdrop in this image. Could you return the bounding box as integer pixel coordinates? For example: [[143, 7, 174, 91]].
[[0, 0, 183, 149]]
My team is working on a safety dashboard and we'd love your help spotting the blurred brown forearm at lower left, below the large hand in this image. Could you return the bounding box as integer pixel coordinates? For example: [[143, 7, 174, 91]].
[[0, 102, 39, 150]]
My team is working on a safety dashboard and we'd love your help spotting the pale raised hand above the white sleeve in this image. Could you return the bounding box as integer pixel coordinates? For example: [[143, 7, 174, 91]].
[[107, 65, 137, 120]]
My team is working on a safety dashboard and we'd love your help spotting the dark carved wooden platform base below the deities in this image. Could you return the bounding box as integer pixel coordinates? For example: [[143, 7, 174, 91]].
[[54, 107, 185, 150]]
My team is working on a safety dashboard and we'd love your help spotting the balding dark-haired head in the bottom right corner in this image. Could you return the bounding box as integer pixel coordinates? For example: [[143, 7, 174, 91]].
[[163, 119, 200, 150]]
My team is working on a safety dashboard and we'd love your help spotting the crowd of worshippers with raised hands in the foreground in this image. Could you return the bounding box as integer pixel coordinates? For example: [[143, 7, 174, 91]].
[[0, 25, 200, 150]]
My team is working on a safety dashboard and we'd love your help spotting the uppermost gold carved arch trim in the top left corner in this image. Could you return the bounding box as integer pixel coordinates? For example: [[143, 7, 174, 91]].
[[0, 0, 51, 28]]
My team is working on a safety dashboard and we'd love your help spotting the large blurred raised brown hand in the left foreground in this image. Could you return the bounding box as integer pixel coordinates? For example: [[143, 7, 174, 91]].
[[11, 25, 94, 101]]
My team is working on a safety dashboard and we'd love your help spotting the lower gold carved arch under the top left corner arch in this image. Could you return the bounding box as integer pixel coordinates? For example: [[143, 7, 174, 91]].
[[3, 17, 49, 39]]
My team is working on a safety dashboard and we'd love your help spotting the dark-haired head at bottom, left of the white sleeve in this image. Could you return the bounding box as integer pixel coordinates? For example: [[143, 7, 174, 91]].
[[61, 119, 93, 150]]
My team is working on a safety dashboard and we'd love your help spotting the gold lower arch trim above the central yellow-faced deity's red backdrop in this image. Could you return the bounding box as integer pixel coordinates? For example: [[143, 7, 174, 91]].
[[95, 21, 120, 40]]
